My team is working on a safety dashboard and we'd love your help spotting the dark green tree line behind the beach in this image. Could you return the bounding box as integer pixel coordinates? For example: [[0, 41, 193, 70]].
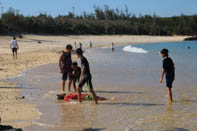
[[0, 6, 197, 36]]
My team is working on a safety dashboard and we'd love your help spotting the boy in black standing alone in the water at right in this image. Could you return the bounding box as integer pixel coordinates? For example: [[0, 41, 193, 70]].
[[160, 49, 175, 102]]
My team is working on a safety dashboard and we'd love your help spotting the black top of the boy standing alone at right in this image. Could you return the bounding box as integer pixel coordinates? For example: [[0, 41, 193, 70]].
[[163, 57, 175, 75]]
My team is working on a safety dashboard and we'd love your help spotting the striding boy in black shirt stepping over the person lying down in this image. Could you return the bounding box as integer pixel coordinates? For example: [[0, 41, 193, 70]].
[[76, 48, 98, 104]]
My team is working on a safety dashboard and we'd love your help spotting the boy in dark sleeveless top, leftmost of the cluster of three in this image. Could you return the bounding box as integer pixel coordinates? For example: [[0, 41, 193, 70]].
[[59, 45, 72, 93]]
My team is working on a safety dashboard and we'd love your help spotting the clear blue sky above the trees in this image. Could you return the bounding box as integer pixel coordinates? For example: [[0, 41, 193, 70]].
[[0, 0, 197, 17]]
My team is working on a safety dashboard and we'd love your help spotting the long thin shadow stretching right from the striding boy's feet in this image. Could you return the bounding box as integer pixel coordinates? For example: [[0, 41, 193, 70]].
[[101, 102, 164, 107]]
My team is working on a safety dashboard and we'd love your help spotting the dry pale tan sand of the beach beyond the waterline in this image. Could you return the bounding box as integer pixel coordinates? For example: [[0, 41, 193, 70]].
[[0, 35, 186, 128]]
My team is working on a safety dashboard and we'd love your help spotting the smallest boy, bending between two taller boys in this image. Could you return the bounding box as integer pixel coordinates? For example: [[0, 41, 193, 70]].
[[68, 62, 81, 92]]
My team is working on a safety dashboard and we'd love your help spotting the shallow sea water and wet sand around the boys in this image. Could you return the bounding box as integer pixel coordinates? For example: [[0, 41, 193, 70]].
[[6, 42, 197, 131]]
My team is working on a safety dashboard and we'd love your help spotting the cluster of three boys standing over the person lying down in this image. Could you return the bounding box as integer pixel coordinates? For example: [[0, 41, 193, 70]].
[[59, 45, 98, 104]]
